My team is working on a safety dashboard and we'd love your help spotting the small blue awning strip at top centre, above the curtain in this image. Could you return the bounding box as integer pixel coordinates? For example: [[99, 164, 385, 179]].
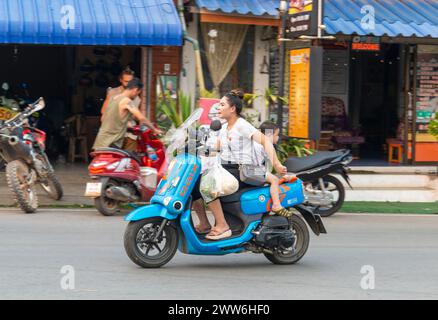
[[196, 0, 280, 16]]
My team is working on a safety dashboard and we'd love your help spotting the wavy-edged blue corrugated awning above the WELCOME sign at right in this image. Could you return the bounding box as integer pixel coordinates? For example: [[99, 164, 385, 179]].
[[324, 0, 438, 38]]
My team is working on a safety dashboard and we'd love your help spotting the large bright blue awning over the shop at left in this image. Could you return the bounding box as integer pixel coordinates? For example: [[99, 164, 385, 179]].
[[0, 0, 183, 46]]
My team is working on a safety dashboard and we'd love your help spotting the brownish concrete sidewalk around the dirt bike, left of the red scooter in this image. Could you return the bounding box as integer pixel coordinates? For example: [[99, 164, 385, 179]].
[[0, 163, 93, 206]]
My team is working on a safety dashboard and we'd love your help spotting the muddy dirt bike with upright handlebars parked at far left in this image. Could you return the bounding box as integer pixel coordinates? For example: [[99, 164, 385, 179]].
[[0, 98, 63, 213]]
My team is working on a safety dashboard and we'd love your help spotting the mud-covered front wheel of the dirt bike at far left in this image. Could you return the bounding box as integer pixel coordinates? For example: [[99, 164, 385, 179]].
[[6, 160, 38, 213]]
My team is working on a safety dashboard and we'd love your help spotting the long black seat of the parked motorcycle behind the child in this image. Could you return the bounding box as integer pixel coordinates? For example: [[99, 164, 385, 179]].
[[286, 150, 345, 173]]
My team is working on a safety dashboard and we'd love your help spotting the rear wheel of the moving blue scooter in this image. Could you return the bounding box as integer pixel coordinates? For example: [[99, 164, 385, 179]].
[[264, 214, 310, 265]]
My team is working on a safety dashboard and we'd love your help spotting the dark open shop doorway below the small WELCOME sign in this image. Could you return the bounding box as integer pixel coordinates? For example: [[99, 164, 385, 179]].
[[350, 44, 403, 165]]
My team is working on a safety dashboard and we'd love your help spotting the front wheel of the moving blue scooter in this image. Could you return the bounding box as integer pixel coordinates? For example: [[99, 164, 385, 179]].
[[124, 218, 178, 268]]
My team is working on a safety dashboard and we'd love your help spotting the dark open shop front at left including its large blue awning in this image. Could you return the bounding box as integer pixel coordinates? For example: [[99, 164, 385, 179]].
[[0, 0, 183, 161]]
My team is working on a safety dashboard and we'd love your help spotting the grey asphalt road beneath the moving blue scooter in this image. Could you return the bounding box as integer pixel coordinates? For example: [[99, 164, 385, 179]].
[[0, 209, 438, 300]]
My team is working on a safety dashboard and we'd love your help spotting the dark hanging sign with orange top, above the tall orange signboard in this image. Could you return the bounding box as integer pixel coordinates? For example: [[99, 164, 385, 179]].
[[285, 0, 318, 39]]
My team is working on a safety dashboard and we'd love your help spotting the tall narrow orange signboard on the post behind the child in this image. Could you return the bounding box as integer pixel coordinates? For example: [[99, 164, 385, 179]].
[[289, 48, 310, 139]]
